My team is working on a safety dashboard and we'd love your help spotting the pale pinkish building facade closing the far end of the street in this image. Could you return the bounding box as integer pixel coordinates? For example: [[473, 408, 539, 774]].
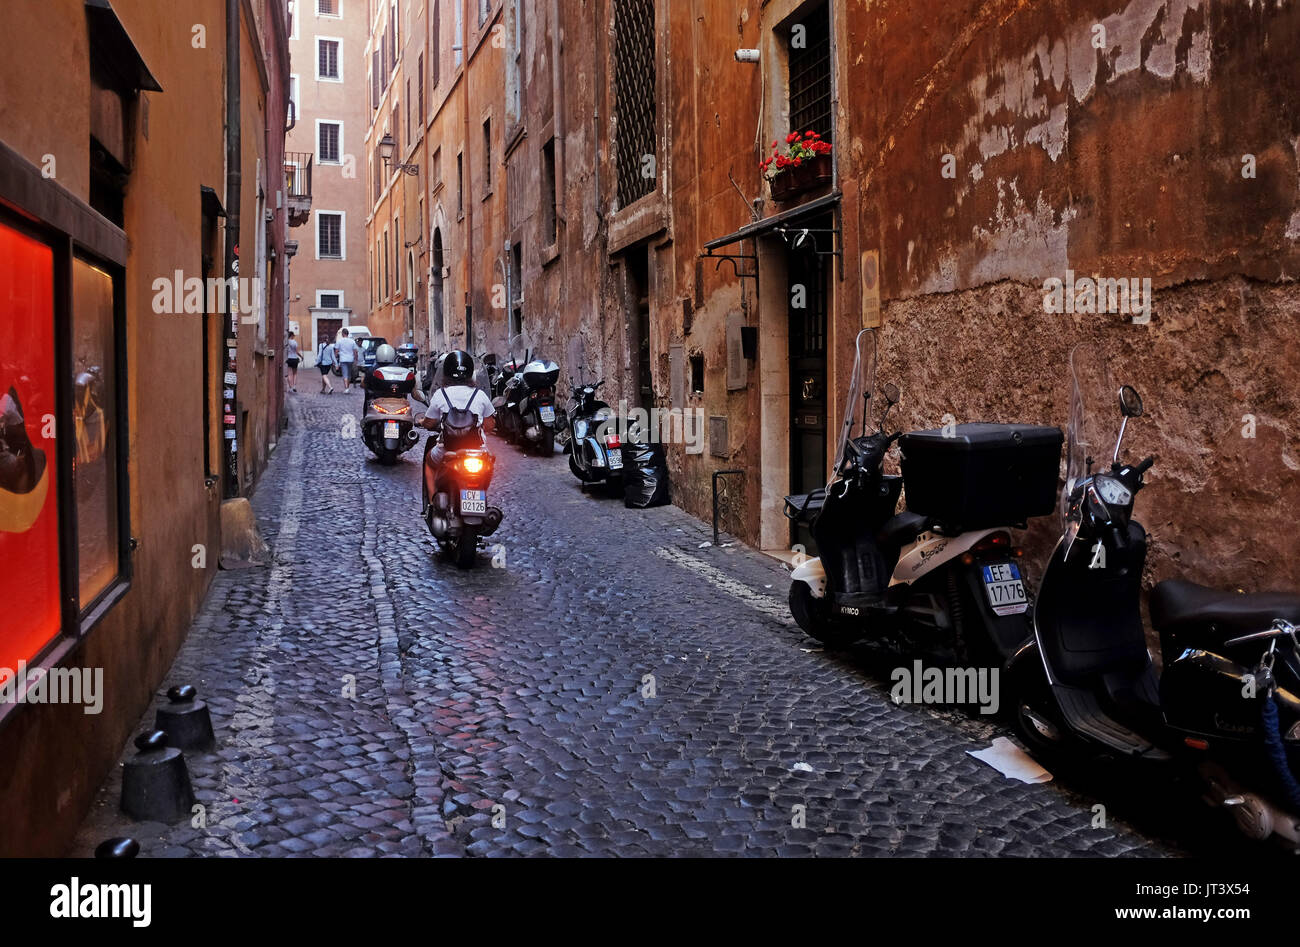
[[286, 0, 369, 366]]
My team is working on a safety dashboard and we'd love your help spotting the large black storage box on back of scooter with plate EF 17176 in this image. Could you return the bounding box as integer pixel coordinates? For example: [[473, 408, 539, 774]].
[[900, 423, 1065, 529]]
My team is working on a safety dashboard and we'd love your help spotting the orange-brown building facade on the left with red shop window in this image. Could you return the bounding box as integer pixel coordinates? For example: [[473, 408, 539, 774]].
[[0, 0, 290, 856]]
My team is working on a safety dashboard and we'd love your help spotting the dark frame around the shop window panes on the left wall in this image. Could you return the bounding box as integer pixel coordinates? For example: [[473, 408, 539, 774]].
[[0, 142, 135, 681]]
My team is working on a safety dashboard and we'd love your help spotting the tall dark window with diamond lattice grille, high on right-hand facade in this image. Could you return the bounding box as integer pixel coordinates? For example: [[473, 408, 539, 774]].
[[614, 0, 658, 207]]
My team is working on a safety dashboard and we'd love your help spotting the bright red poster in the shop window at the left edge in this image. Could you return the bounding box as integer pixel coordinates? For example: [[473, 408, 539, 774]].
[[0, 224, 59, 680]]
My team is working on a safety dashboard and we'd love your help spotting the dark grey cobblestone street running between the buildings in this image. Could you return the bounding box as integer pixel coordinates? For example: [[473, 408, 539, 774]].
[[72, 385, 1178, 856]]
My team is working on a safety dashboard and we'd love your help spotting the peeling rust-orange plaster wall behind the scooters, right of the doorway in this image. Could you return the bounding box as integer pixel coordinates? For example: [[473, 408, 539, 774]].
[[836, 0, 1300, 589]]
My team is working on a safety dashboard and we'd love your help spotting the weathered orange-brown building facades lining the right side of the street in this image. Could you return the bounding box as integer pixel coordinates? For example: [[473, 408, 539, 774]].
[[382, 0, 1300, 587]]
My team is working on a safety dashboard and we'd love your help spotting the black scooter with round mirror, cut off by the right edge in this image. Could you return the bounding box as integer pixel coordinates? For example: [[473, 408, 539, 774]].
[[1013, 351, 1300, 846]]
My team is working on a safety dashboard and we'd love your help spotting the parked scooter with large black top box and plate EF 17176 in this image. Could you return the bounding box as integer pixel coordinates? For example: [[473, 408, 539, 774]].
[[785, 329, 1062, 667]]
